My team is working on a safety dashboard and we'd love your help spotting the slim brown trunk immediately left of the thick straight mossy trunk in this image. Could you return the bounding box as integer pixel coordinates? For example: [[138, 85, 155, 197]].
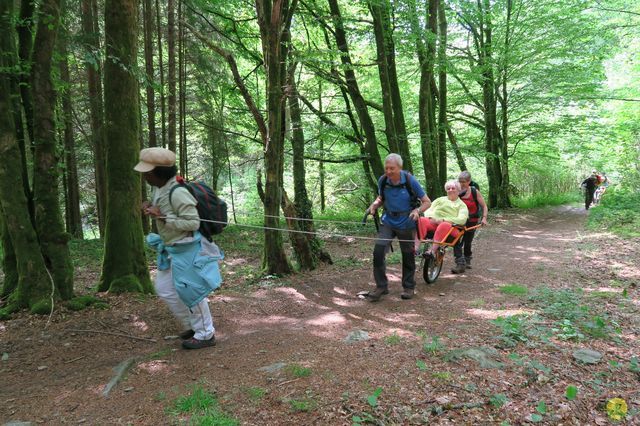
[[82, 0, 107, 237]]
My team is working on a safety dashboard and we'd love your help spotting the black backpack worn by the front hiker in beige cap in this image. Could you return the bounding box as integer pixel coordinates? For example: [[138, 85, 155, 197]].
[[169, 178, 228, 241]]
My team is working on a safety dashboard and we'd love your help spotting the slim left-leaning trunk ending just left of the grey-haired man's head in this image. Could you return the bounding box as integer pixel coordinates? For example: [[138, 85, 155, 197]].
[[328, 0, 384, 177]]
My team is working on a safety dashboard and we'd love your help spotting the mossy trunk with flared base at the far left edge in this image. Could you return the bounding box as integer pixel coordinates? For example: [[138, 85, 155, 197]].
[[0, 2, 52, 319]]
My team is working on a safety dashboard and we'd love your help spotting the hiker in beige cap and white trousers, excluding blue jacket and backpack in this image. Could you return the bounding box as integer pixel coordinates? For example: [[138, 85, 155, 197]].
[[134, 148, 215, 349]]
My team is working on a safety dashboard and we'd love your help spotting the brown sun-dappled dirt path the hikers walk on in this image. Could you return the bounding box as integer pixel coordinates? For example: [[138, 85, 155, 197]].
[[0, 207, 640, 425]]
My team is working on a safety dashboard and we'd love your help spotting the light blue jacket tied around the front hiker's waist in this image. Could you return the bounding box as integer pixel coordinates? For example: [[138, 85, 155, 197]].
[[147, 232, 224, 308]]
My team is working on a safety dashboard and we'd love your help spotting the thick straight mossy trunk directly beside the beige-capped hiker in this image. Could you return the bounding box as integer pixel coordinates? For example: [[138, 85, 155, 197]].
[[98, 0, 153, 293]]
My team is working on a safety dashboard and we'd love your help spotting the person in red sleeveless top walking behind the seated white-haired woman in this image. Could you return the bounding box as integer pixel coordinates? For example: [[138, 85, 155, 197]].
[[451, 170, 489, 274]]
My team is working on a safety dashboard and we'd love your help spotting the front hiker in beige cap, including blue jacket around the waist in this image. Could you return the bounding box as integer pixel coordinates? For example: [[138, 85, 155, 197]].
[[134, 148, 222, 349]]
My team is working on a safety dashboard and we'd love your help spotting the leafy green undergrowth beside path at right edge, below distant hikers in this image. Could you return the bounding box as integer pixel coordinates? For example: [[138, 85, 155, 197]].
[[587, 188, 640, 238]]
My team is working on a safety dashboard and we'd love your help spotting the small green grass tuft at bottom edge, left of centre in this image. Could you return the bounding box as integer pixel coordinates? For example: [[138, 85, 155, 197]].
[[169, 384, 240, 426]]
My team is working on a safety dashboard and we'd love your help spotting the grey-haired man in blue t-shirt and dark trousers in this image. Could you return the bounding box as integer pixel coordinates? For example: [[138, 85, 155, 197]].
[[369, 154, 431, 302]]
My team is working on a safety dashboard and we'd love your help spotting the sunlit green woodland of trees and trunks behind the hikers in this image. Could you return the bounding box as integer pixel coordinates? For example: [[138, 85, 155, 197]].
[[0, 0, 640, 312]]
